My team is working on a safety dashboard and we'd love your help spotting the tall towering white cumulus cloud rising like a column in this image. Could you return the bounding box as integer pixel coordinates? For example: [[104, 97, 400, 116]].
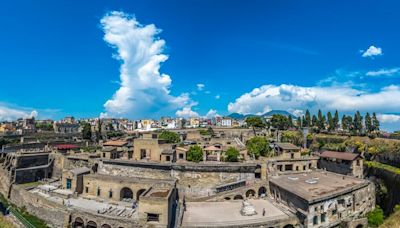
[[101, 11, 192, 118]]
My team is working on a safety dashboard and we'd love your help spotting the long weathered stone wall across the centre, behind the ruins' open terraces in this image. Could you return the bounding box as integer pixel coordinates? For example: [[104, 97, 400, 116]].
[[98, 161, 257, 197]]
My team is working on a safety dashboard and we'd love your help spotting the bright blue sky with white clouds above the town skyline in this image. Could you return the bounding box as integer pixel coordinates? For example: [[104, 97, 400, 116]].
[[0, 0, 400, 128]]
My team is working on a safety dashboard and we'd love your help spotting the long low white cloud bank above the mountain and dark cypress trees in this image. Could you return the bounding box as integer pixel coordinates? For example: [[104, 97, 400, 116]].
[[228, 84, 400, 114]]
